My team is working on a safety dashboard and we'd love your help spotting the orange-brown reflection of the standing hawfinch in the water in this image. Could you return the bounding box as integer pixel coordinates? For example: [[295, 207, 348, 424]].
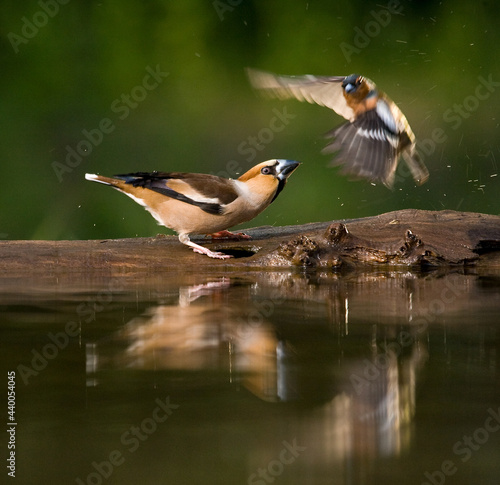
[[114, 278, 277, 401]]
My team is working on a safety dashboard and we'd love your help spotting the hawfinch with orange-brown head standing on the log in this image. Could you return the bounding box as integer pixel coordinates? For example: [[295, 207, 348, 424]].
[[85, 160, 299, 259]]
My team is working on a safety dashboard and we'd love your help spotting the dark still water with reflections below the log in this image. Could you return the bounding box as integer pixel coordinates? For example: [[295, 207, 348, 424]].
[[0, 271, 500, 484]]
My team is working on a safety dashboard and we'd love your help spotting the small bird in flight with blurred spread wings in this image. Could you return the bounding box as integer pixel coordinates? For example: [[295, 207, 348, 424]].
[[247, 69, 429, 187]]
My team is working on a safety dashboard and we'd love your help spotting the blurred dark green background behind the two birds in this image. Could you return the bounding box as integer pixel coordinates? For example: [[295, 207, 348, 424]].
[[0, 0, 500, 239]]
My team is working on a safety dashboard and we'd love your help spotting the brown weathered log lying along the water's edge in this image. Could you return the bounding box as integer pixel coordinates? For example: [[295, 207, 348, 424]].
[[0, 209, 500, 272]]
